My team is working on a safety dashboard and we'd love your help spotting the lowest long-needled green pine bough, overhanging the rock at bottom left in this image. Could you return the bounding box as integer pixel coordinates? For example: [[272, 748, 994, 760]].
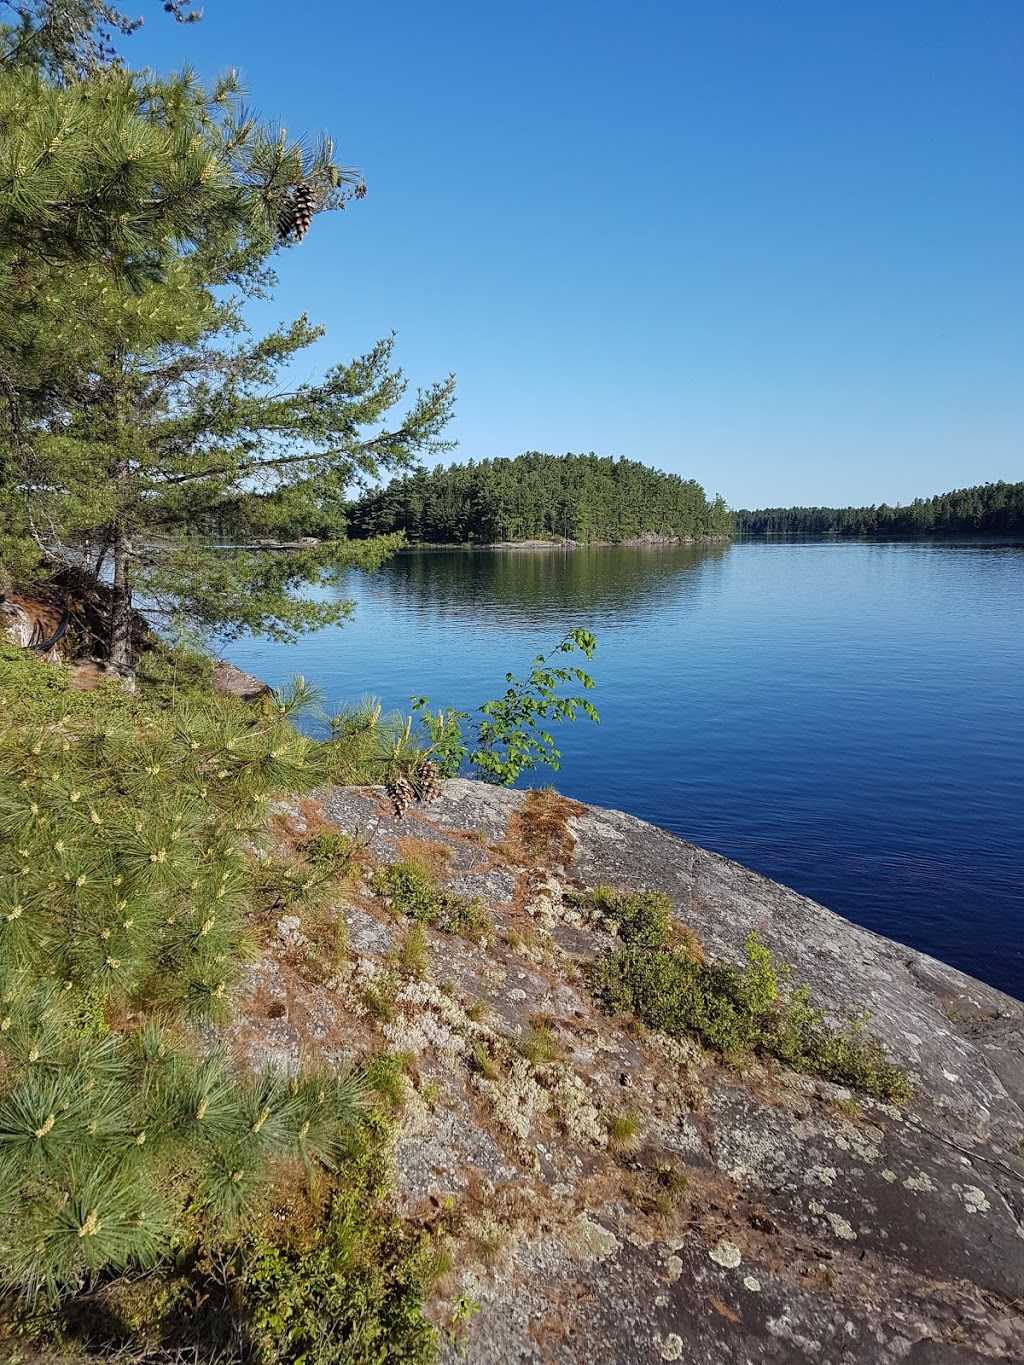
[[0, 973, 363, 1301]]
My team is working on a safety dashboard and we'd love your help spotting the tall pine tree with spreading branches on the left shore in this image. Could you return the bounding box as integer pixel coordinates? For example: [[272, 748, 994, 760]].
[[0, 8, 452, 667]]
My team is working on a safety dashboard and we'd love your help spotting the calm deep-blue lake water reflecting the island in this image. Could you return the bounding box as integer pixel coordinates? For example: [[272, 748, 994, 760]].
[[225, 542, 1024, 996]]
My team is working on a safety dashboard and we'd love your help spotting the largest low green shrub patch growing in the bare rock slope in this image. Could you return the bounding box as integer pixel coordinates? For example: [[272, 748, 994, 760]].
[[590, 936, 912, 1103]]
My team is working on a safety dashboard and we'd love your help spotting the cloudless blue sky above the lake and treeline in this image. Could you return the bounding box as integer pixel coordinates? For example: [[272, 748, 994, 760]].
[[124, 0, 1024, 506]]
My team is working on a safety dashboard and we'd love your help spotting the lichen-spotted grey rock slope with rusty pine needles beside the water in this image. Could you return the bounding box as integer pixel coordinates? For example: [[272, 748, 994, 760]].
[[231, 781, 1024, 1365]]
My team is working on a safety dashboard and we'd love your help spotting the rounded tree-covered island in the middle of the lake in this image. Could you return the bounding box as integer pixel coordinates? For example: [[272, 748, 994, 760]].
[[347, 452, 732, 545]]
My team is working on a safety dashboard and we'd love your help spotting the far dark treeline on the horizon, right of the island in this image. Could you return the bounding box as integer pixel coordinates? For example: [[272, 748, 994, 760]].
[[732, 483, 1024, 535]]
